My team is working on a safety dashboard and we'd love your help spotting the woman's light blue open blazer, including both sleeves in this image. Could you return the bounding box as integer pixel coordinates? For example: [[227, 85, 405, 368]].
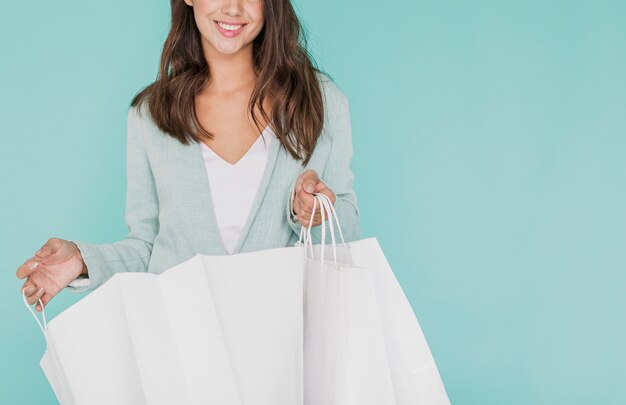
[[67, 73, 360, 292]]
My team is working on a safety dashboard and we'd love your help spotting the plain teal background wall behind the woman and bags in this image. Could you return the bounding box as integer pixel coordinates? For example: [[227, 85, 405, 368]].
[[0, 0, 626, 404]]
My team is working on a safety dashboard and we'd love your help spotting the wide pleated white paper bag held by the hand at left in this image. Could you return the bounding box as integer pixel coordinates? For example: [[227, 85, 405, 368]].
[[24, 247, 304, 405]]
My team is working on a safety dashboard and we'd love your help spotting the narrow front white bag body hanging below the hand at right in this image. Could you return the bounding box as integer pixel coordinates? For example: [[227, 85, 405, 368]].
[[304, 259, 395, 405]]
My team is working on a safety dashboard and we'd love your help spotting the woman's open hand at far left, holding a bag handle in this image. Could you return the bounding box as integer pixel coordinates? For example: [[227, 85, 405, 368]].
[[16, 238, 87, 312]]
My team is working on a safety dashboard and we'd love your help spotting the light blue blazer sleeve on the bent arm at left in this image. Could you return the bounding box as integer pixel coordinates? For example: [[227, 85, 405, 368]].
[[66, 107, 159, 292]]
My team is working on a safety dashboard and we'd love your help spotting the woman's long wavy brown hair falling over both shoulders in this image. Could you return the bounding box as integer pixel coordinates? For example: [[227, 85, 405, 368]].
[[131, 0, 332, 165]]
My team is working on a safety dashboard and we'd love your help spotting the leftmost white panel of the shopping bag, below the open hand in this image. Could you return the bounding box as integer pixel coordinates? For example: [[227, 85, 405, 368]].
[[47, 280, 146, 405]]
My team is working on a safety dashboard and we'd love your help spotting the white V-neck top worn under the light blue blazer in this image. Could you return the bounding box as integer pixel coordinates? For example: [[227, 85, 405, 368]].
[[200, 126, 275, 254]]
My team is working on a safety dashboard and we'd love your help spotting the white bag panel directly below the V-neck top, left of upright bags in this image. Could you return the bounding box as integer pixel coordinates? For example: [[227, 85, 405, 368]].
[[202, 248, 303, 405]]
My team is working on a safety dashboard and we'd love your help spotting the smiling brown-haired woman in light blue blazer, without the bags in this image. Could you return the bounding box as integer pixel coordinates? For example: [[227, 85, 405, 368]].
[[17, 0, 360, 311]]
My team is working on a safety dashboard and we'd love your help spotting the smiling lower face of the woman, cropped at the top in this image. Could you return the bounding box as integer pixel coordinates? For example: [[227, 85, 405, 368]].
[[185, 0, 264, 54]]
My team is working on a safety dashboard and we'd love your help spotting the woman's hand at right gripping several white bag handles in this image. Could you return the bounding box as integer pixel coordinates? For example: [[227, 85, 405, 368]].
[[292, 170, 337, 227]]
